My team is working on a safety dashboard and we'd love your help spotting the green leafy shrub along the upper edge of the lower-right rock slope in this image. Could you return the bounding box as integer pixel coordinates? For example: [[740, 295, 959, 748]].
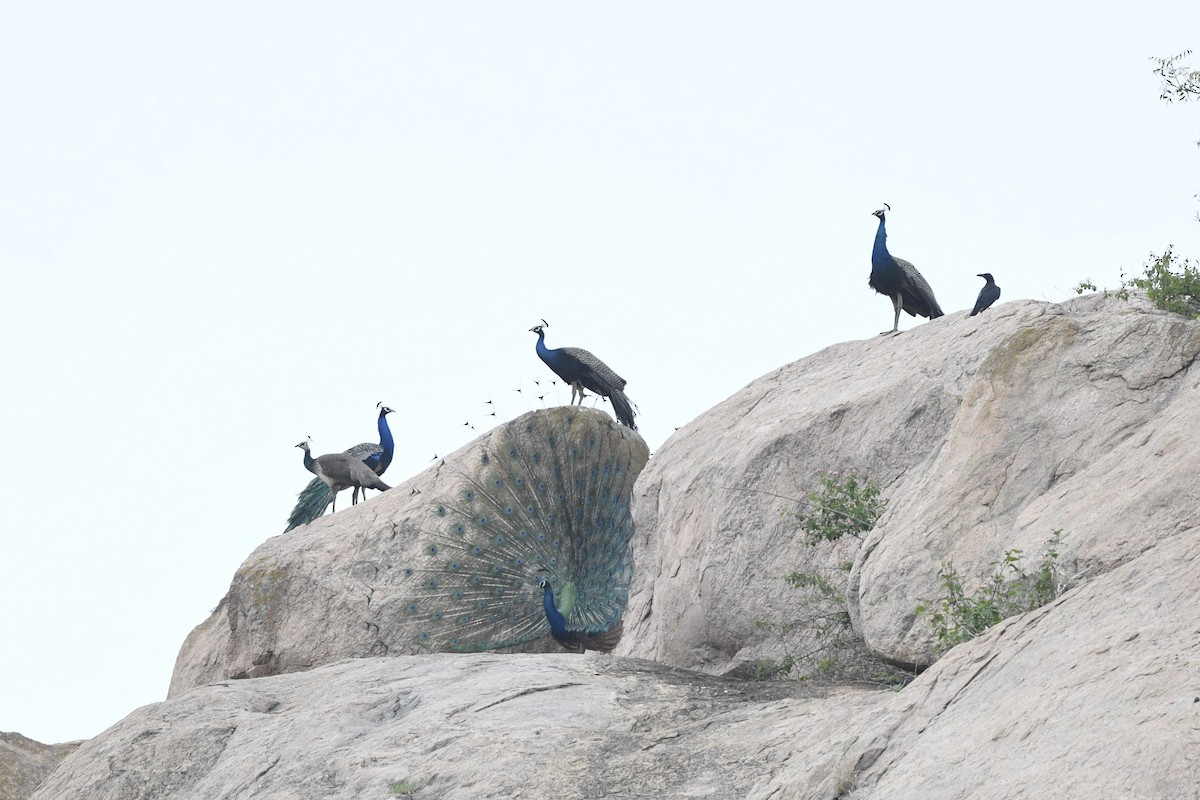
[[917, 530, 1062, 654]]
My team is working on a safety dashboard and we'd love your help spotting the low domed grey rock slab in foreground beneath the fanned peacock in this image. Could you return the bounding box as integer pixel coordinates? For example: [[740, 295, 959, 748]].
[[34, 654, 880, 800]]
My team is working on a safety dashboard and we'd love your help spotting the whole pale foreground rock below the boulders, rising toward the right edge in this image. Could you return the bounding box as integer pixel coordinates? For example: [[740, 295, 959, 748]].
[[34, 531, 1200, 800]]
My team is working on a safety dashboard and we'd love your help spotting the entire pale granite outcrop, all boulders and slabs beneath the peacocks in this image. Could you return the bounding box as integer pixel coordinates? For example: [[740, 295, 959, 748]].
[[34, 296, 1200, 800]]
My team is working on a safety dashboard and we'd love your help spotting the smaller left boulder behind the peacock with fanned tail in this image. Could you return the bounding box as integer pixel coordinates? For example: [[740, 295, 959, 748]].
[[168, 408, 649, 697]]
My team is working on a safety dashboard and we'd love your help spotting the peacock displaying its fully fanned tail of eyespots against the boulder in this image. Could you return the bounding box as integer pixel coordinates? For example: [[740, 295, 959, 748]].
[[403, 407, 649, 652]]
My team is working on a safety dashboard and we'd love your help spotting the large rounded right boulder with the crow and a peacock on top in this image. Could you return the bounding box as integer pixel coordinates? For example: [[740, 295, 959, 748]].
[[617, 295, 1200, 674]]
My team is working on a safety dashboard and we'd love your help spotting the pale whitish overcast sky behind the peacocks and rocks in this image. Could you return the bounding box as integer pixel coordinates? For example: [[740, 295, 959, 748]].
[[0, 0, 1200, 742]]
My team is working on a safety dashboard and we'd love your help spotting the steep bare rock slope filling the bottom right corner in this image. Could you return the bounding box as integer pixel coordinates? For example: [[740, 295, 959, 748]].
[[851, 530, 1200, 800]]
